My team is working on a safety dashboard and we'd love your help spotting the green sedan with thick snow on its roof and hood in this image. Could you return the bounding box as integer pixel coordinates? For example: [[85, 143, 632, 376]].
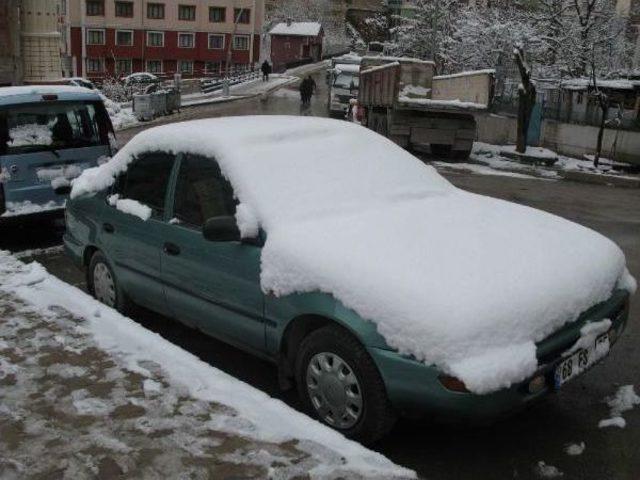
[[64, 116, 635, 441]]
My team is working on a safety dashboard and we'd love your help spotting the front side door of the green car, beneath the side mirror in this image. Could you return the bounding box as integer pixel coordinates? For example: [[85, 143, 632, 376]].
[[161, 155, 265, 352]]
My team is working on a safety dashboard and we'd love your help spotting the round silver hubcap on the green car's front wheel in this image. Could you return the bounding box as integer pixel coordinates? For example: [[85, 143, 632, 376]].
[[307, 352, 362, 429]]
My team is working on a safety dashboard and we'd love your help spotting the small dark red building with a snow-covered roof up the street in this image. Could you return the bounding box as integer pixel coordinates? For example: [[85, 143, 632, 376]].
[[269, 20, 324, 72]]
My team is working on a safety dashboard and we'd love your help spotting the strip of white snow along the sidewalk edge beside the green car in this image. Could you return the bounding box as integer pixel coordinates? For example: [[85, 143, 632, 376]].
[[0, 252, 416, 479]]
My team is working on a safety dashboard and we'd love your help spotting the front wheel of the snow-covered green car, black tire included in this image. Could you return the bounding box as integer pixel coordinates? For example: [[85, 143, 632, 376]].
[[295, 325, 396, 444]]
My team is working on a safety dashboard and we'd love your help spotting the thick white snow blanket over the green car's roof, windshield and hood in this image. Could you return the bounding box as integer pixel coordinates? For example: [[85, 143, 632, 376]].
[[72, 116, 635, 393]]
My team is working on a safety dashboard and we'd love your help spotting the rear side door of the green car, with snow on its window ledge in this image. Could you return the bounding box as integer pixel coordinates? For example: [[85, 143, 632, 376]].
[[100, 152, 175, 312]]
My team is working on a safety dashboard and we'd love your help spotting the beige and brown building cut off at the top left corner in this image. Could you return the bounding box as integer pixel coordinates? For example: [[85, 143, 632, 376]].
[[0, 0, 63, 85]]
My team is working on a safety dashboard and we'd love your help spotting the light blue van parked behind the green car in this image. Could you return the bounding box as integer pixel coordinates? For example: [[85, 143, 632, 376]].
[[0, 86, 116, 220]]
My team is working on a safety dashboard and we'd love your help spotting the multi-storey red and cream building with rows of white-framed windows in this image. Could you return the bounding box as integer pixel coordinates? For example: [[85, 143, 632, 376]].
[[66, 0, 264, 78]]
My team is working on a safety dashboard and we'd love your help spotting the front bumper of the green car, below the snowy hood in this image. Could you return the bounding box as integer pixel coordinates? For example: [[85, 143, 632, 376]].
[[368, 292, 629, 423]]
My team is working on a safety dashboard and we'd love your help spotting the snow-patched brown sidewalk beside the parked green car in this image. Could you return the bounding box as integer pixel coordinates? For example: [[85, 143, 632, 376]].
[[0, 252, 415, 479]]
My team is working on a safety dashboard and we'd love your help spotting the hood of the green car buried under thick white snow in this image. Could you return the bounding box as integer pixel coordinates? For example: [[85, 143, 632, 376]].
[[261, 190, 628, 393]]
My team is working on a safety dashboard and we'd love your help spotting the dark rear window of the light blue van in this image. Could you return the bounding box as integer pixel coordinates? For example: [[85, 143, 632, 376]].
[[0, 102, 112, 155]]
